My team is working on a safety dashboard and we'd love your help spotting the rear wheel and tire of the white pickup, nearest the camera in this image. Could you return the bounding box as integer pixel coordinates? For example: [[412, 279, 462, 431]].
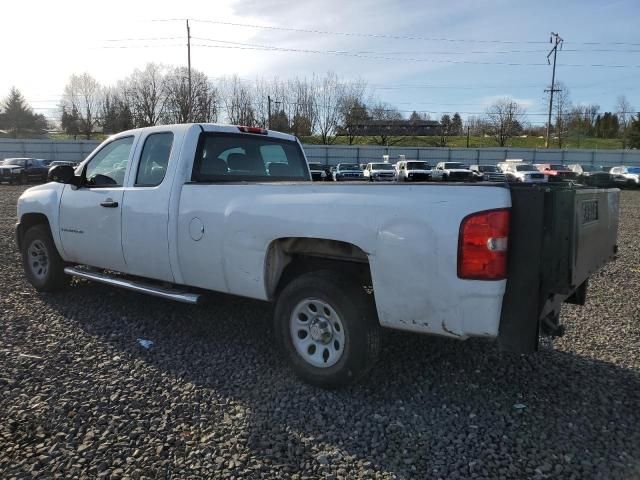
[[274, 270, 380, 388]]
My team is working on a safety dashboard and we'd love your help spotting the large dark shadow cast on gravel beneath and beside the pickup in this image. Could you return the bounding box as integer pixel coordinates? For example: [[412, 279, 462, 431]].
[[41, 281, 640, 478]]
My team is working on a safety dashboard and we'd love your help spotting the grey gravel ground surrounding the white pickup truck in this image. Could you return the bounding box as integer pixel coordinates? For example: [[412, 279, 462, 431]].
[[0, 186, 640, 479]]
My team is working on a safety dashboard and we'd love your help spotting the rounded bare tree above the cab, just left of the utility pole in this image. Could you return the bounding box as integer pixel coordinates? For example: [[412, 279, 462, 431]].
[[123, 63, 166, 127]]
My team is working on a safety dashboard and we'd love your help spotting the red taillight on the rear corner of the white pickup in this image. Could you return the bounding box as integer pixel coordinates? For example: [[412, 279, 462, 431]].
[[458, 209, 509, 280]]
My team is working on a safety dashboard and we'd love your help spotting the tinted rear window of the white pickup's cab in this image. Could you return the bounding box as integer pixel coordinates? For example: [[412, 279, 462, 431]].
[[191, 133, 310, 182]]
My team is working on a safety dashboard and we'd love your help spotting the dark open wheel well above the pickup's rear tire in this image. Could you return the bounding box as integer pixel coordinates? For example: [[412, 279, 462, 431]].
[[265, 237, 371, 298]]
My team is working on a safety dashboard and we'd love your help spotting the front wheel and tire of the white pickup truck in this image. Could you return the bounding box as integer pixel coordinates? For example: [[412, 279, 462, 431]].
[[21, 225, 70, 292]]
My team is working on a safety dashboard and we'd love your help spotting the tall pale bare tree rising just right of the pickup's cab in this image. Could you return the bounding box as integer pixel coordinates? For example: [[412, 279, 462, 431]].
[[314, 72, 345, 145]]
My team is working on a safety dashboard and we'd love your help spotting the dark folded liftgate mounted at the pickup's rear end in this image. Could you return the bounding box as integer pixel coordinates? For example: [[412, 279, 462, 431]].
[[498, 184, 620, 353]]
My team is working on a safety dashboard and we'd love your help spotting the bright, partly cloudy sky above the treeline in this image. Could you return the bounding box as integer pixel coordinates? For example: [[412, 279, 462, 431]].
[[0, 0, 640, 125]]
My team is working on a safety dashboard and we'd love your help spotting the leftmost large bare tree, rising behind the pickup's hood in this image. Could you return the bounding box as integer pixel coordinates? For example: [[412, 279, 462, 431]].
[[62, 73, 103, 140]]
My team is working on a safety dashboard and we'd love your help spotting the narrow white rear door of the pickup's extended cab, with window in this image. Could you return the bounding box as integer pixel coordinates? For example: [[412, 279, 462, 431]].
[[122, 130, 178, 282]]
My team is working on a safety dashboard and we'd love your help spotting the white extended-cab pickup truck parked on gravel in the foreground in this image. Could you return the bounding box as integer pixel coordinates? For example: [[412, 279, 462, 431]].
[[16, 124, 618, 387]]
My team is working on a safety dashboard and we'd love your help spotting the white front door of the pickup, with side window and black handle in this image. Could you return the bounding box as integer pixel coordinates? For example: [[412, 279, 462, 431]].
[[60, 135, 136, 271]]
